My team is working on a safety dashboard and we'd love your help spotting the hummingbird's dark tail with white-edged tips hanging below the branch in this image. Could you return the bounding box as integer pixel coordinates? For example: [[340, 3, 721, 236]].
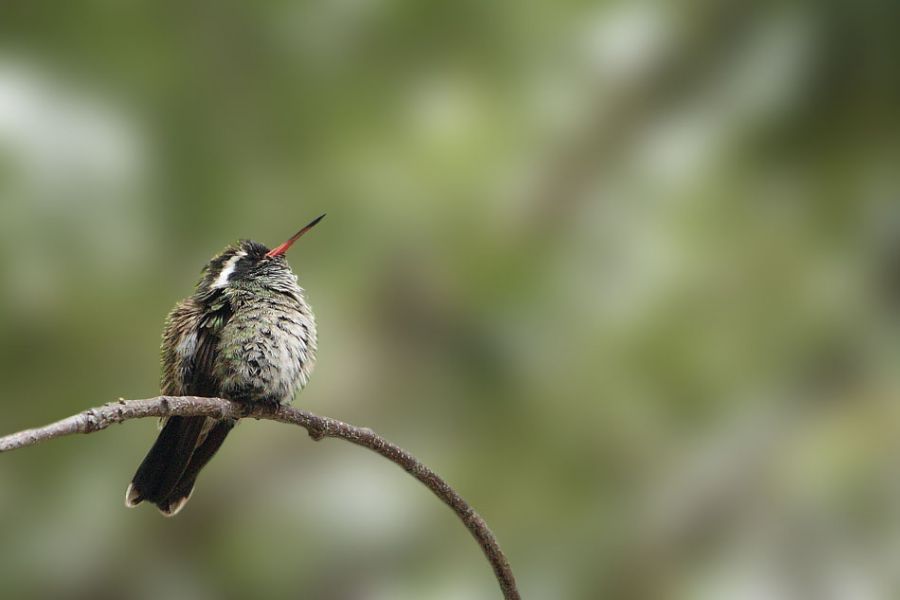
[[125, 417, 235, 517]]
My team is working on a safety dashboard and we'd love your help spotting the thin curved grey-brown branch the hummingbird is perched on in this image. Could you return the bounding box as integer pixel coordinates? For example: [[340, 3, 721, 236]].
[[0, 396, 519, 600]]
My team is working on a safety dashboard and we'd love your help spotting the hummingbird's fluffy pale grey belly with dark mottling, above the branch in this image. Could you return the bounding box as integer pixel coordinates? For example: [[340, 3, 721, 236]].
[[217, 307, 316, 403]]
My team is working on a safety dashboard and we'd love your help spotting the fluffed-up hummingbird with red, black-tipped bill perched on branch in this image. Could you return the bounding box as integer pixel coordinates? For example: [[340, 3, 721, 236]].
[[125, 215, 325, 517]]
